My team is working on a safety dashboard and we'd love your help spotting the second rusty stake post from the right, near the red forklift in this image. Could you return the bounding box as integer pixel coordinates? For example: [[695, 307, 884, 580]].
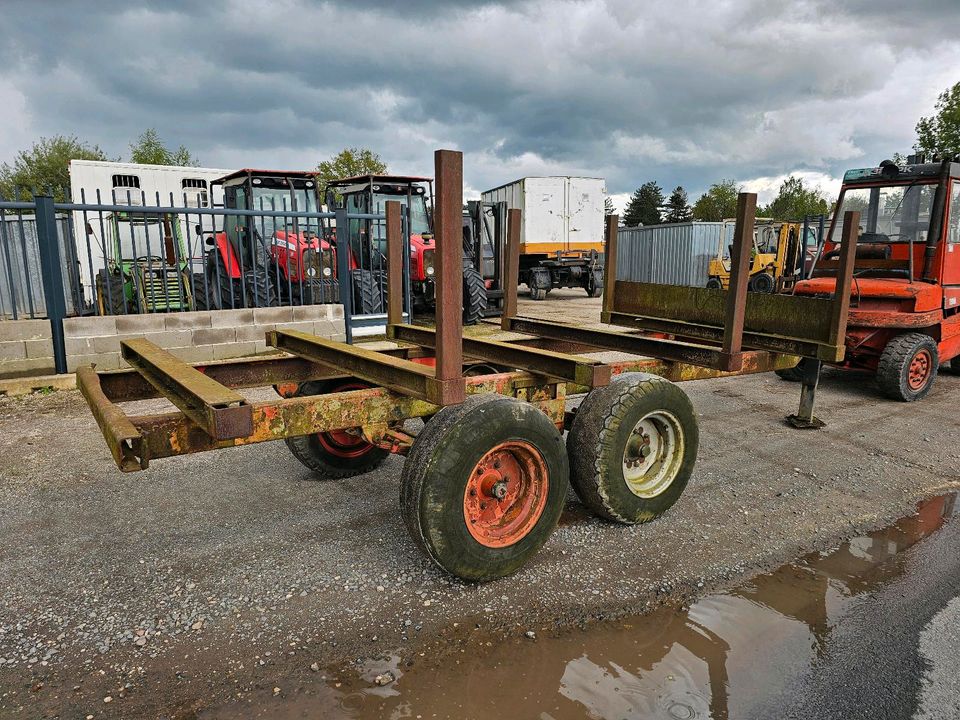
[[720, 193, 757, 372]]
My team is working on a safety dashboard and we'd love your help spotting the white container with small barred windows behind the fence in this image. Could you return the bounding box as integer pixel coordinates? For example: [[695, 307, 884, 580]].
[[70, 160, 233, 306]]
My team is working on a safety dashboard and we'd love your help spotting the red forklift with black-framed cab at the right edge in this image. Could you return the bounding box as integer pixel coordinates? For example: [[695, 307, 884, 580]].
[[778, 157, 960, 401]]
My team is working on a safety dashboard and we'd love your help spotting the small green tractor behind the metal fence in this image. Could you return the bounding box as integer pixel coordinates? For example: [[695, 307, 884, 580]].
[[94, 212, 194, 315]]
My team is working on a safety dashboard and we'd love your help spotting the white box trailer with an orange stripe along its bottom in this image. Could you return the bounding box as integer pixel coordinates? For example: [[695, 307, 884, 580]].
[[482, 176, 607, 300]]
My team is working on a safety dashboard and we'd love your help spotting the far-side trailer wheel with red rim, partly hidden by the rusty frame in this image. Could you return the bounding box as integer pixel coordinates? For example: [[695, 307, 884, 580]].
[[284, 379, 390, 480]]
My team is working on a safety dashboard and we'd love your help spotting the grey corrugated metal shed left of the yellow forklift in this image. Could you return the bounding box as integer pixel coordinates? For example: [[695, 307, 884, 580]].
[[617, 222, 724, 287]]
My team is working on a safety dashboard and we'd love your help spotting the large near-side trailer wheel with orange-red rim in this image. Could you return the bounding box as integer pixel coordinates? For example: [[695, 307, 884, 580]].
[[400, 394, 569, 581]]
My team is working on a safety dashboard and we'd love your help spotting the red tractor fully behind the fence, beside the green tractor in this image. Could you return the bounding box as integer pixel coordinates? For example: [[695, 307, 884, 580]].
[[195, 169, 339, 308]]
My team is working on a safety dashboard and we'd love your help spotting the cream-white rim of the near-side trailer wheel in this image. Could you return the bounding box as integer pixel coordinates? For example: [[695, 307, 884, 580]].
[[622, 410, 684, 498]]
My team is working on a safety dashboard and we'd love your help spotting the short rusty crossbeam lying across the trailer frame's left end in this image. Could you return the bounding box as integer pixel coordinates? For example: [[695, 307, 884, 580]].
[[120, 338, 253, 440]]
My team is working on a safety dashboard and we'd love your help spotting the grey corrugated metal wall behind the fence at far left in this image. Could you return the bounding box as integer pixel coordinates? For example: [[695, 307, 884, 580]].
[[0, 215, 82, 320]]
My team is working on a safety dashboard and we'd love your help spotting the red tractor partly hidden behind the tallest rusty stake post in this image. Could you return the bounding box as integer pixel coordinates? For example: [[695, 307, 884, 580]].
[[326, 175, 487, 324]]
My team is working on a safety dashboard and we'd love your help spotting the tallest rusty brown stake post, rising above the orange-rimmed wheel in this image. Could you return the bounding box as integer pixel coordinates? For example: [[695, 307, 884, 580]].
[[433, 150, 466, 405]]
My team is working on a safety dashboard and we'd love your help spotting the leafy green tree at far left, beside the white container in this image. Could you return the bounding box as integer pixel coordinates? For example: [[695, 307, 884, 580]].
[[0, 135, 109, 202]]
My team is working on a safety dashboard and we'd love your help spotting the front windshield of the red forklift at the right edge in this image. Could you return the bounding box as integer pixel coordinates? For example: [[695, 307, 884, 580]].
[[830, 183, 937, 243]]
